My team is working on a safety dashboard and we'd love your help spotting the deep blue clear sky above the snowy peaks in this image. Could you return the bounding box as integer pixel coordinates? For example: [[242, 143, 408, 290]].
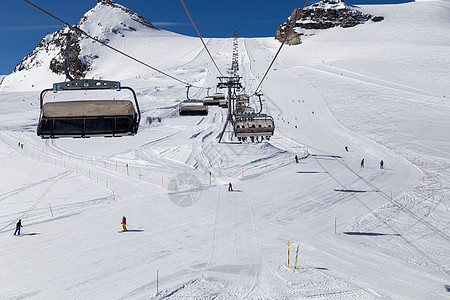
[[0, 0, 410, 74]]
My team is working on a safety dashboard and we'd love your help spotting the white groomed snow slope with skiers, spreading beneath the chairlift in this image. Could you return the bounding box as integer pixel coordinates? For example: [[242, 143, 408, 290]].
[[0, 1, 450, 299]]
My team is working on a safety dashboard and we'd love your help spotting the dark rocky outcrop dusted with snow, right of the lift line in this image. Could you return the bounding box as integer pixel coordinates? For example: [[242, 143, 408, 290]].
[[275, 0, 384, 44]]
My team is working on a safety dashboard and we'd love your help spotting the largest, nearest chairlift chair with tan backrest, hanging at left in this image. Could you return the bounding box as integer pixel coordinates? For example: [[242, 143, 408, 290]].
[[37, 79, 141, 139]]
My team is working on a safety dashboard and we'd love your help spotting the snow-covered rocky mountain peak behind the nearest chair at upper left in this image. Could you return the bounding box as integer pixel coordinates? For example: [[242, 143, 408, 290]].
[[8, 0, 159, 78]]
